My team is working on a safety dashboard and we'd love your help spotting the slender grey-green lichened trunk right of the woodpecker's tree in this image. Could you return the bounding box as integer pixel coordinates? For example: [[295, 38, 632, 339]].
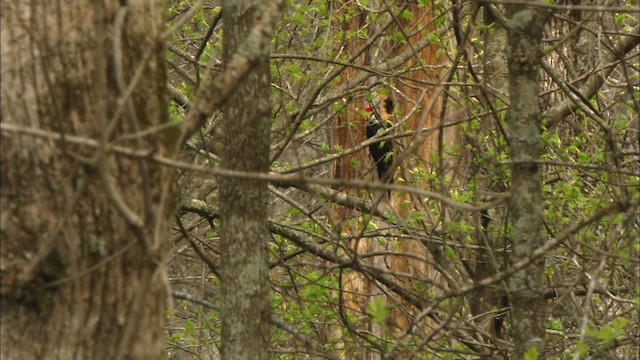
[[506, 2, 547, 359]]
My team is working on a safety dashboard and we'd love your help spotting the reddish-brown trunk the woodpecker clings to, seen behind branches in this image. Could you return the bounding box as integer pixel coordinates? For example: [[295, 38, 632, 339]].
[[330, 1, 444, 360]]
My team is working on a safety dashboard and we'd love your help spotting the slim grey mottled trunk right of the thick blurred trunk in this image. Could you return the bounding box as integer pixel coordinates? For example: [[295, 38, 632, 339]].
[[220, 1, 279, 360]]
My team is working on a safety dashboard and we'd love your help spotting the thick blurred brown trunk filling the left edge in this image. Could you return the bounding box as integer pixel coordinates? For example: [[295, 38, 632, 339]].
[[0, 0, 173, 359]]
